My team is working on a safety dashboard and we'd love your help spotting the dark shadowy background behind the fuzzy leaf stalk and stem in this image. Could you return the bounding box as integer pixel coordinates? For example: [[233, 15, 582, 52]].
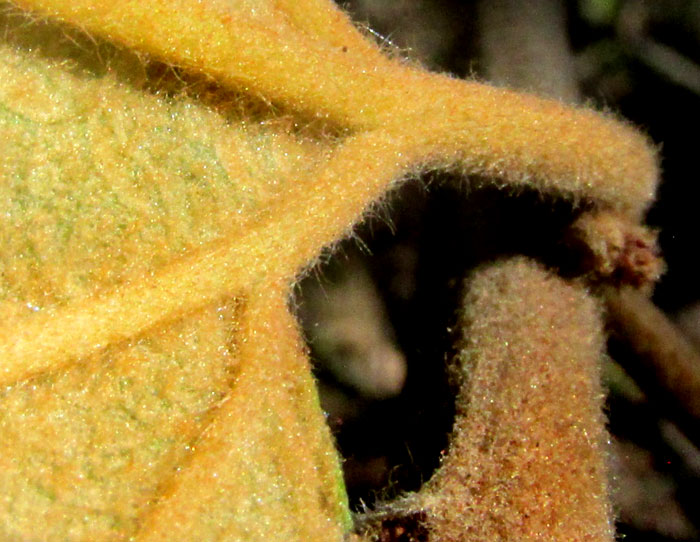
[[304, 0, 700, 541]]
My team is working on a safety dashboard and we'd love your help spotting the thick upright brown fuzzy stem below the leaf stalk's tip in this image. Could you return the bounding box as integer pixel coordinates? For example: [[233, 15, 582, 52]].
[[419, 259, 613, 542]]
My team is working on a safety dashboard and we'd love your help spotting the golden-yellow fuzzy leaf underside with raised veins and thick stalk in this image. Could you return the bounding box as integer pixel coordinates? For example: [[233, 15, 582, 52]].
[[0, 0, 657, 541]]
